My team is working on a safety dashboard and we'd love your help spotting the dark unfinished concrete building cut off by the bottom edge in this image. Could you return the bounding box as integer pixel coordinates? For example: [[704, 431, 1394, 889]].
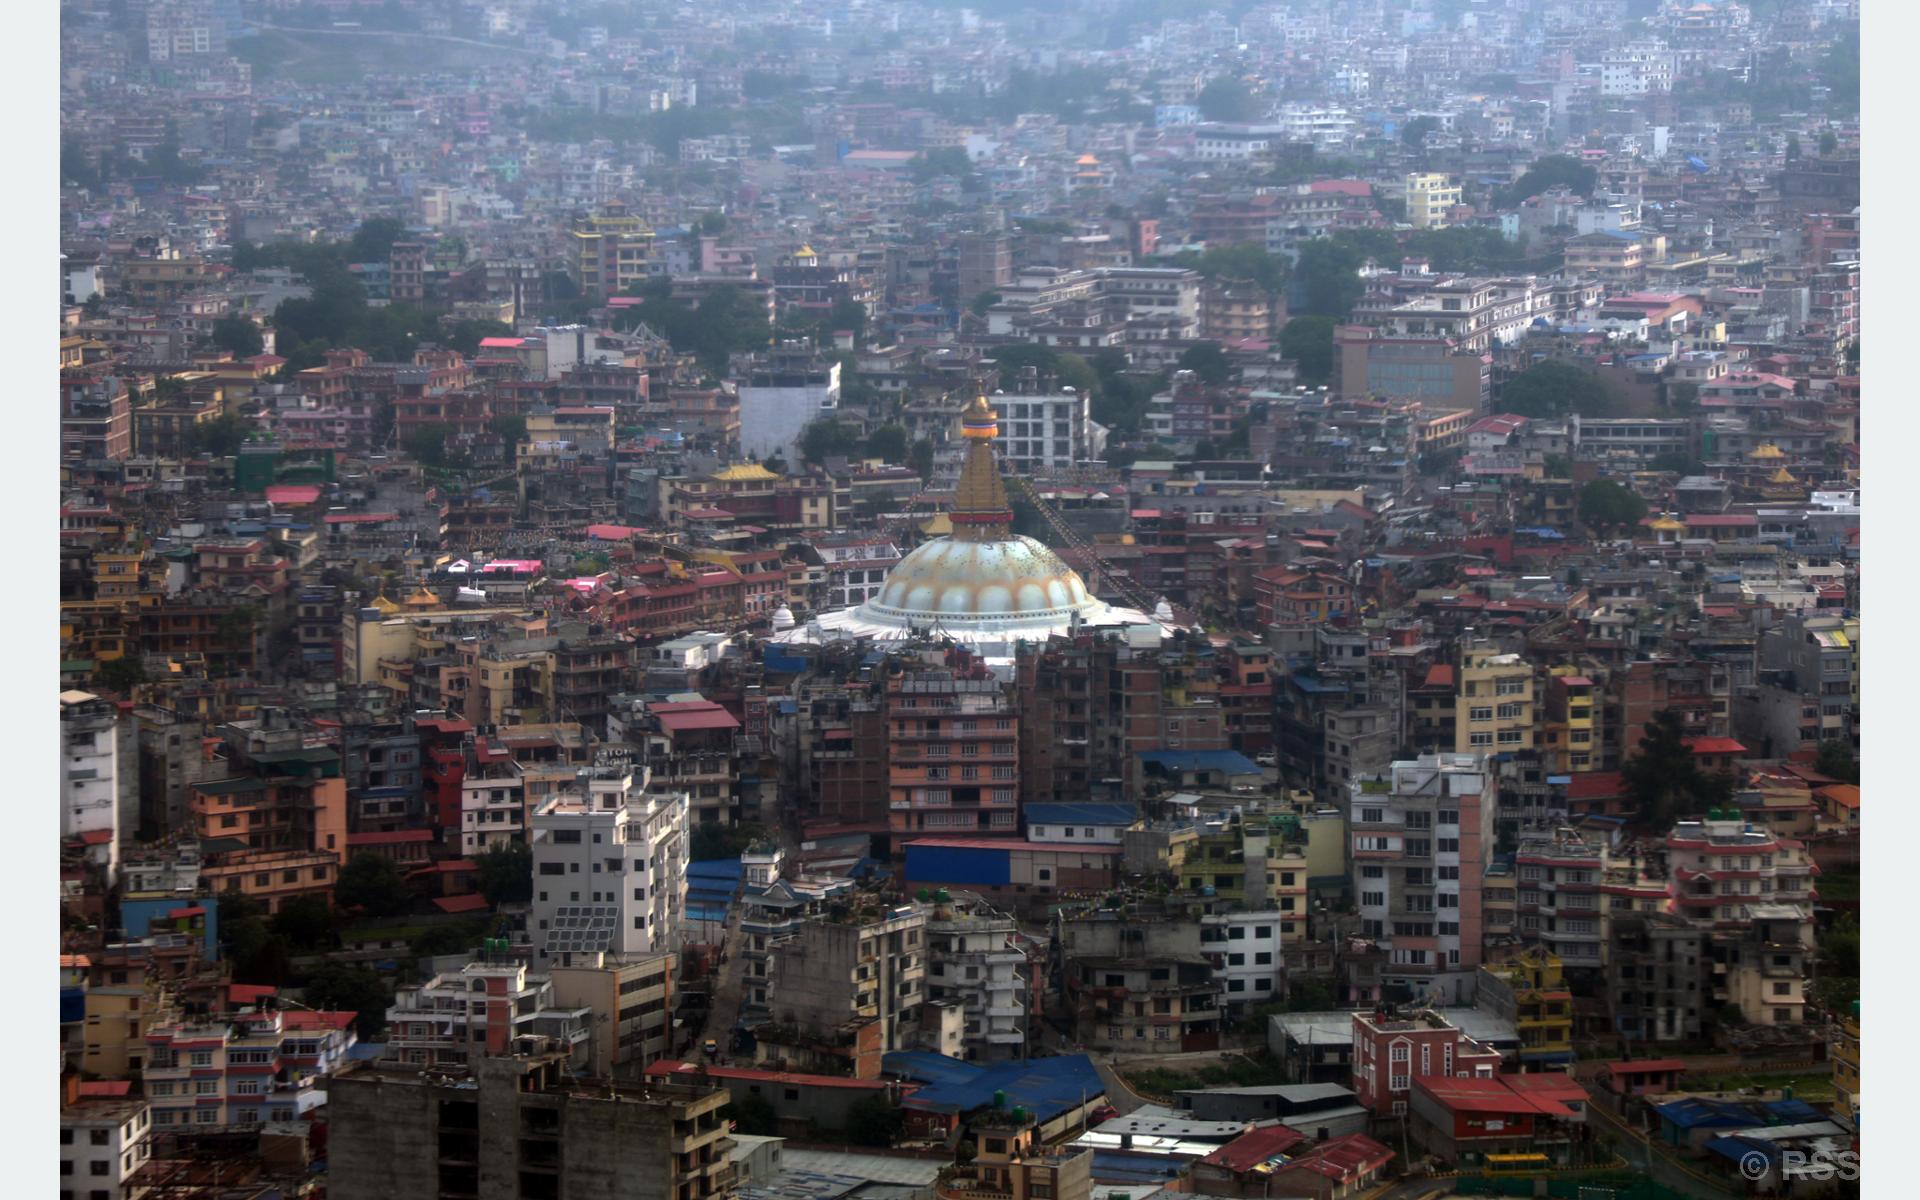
[[326, 1039, 733, 1200]]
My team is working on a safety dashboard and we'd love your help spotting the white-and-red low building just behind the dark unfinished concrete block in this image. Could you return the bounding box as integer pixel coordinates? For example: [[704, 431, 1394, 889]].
[[386, 956, 595, 1068]]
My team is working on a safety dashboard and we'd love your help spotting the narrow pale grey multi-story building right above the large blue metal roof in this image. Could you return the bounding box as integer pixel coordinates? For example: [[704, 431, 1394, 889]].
[[927, 900, 1033, 1062]]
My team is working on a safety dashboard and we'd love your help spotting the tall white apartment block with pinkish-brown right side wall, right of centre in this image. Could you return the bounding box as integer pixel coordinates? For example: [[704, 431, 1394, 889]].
[[1348, 755, 1496, 1004]]
